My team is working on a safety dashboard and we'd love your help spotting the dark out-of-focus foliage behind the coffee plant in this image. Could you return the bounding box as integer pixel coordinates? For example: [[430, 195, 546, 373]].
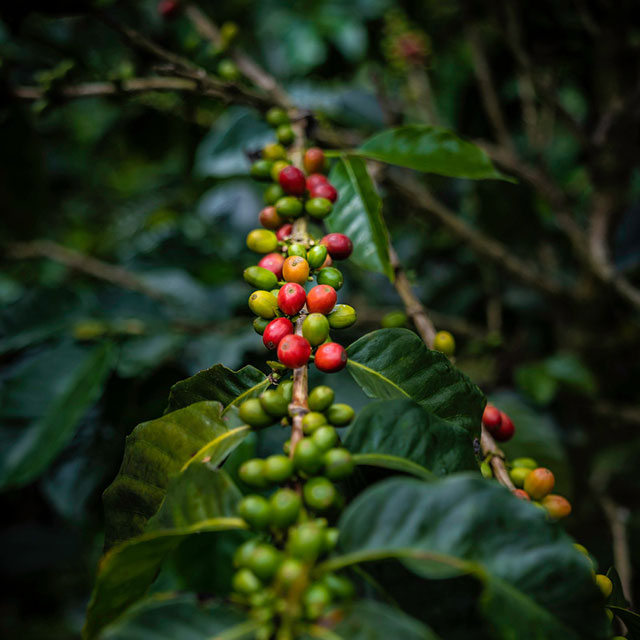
[[0, 0, 640, 640]]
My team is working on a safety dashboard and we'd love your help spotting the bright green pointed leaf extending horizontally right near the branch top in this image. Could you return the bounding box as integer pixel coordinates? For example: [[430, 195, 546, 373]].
[[353, 124, 515, 182]]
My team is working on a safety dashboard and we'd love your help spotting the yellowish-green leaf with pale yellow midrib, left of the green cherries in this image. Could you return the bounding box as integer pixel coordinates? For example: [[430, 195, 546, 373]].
[[103, 402, 249, 549]]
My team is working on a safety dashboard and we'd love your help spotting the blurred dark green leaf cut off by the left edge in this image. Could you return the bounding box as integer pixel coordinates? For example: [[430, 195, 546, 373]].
[[0, 342, 115, 487]]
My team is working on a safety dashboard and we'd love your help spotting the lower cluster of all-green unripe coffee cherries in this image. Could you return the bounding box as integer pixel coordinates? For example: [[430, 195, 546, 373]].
[[232, 381, 355, 638]]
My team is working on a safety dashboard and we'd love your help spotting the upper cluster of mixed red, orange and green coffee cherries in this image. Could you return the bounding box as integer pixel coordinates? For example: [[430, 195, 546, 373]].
[[243, 109, 356, 373]]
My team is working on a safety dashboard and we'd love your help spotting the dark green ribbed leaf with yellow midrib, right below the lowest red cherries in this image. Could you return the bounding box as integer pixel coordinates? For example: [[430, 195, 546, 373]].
[[347, 329, 485, 434]]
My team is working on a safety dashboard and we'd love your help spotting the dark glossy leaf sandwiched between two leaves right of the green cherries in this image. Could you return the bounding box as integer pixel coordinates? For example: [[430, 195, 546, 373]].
[[344, 399, 478, 476]]
